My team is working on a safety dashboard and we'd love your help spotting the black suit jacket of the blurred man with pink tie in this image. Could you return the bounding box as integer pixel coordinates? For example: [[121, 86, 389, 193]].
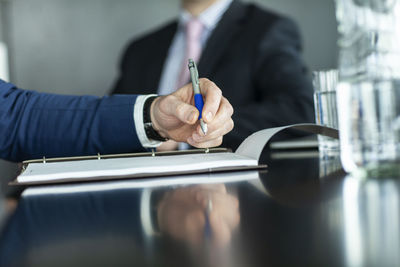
[[113, 1, 314, 149]]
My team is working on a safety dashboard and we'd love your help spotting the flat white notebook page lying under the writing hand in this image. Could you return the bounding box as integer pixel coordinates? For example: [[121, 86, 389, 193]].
[[17, 153, 258, 183]]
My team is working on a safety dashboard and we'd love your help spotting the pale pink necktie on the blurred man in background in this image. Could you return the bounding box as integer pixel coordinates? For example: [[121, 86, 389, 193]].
[[177, 18, 203, 88]]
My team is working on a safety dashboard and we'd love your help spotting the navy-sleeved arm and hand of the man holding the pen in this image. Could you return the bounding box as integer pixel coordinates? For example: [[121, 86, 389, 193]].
[[0, 79, 233, 161]]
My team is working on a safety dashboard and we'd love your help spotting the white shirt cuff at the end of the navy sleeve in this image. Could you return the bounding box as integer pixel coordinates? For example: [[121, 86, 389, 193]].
[[133, 95, 162, 148]]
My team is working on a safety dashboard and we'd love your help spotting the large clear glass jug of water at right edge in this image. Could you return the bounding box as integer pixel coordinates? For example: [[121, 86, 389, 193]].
[[336, 0, 400, 176]]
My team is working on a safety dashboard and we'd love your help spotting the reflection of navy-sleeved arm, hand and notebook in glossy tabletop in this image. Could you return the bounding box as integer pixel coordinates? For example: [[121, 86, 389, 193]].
[[0, 171, 258, 266]]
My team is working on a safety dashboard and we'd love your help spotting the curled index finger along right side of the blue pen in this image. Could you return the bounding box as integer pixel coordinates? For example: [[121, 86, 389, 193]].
[[199, 78, 222, 123]]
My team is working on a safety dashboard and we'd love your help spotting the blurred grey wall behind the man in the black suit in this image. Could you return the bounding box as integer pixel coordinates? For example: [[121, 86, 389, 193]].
[[0, 0, 337, 187]]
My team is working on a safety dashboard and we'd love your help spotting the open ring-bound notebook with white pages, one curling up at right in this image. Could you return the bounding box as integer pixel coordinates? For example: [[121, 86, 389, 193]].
[[10, 124, 337, 185]]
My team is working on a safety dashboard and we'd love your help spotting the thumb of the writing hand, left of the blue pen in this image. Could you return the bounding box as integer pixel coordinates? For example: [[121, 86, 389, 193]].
[[160, 95, 199, 124]]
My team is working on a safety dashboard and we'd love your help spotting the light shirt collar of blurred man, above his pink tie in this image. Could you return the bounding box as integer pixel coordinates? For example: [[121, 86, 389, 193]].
[[179, 0, 233, 30]]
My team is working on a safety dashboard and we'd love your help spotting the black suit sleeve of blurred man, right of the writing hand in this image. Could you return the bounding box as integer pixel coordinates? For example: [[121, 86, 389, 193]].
[[225, 18, 314, 148]]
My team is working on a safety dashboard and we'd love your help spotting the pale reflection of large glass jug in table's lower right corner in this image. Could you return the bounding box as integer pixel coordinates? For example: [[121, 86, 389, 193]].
[[343, 177, 400, 266]]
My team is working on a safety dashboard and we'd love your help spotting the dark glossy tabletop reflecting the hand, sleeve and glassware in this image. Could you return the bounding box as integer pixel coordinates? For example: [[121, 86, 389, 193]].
[[0, 151, 400, 267]]
